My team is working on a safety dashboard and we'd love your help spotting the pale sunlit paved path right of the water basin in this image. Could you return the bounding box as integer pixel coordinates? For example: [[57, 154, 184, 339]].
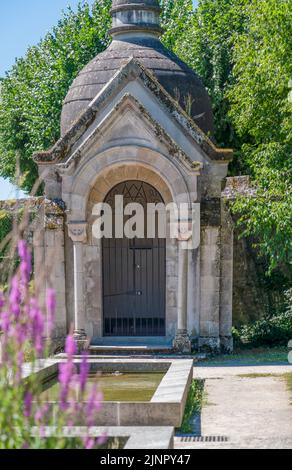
[[175, 365, 292, 449]]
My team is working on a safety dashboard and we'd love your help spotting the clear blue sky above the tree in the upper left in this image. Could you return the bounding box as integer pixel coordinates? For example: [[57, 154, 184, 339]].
[[0, 0, 197, 200]]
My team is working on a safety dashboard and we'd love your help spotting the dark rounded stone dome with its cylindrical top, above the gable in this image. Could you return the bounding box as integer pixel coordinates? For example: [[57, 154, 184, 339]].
[[61, 0, 213, 135]]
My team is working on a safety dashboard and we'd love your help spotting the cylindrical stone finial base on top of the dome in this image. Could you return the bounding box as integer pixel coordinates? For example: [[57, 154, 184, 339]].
[[110, 0, 162, 36]]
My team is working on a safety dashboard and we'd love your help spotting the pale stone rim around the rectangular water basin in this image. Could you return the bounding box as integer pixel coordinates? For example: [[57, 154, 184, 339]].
[[22, 355, 193, 427]]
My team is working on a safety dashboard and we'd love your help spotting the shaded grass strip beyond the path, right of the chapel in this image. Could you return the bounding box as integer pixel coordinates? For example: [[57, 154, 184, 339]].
[[200, 347, 289, 366]]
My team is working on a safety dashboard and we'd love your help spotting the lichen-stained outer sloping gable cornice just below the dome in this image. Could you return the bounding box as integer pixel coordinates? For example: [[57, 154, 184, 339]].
[[34, 58, 233, 165]]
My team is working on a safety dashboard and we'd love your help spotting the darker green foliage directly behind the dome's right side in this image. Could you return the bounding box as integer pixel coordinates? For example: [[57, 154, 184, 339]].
[[174, 0, 250, 148]]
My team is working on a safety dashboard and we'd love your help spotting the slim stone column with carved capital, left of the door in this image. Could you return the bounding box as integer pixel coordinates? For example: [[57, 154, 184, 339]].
[[68, 222, 87, 350]]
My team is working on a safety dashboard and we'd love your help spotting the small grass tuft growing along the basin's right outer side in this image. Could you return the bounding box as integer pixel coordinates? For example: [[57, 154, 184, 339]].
[[178, 380, 206, 434]]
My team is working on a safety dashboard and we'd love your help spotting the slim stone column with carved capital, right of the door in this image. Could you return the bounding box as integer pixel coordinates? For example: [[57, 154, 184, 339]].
[[173, 217, 192, 353]]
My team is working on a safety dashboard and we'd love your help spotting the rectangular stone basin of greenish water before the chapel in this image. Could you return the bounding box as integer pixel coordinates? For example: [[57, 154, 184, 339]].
[[23, 355, 193, 449]]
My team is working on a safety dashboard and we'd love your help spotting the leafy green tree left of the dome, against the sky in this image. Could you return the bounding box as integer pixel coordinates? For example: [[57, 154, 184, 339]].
[[0, 0, 111, 190]]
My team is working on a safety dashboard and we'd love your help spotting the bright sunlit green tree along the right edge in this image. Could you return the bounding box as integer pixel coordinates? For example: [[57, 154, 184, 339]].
[[227, 0, 292, 271]]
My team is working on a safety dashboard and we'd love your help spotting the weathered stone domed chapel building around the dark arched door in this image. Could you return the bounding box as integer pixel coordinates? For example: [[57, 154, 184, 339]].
[[29, 0, 237, 352]]
